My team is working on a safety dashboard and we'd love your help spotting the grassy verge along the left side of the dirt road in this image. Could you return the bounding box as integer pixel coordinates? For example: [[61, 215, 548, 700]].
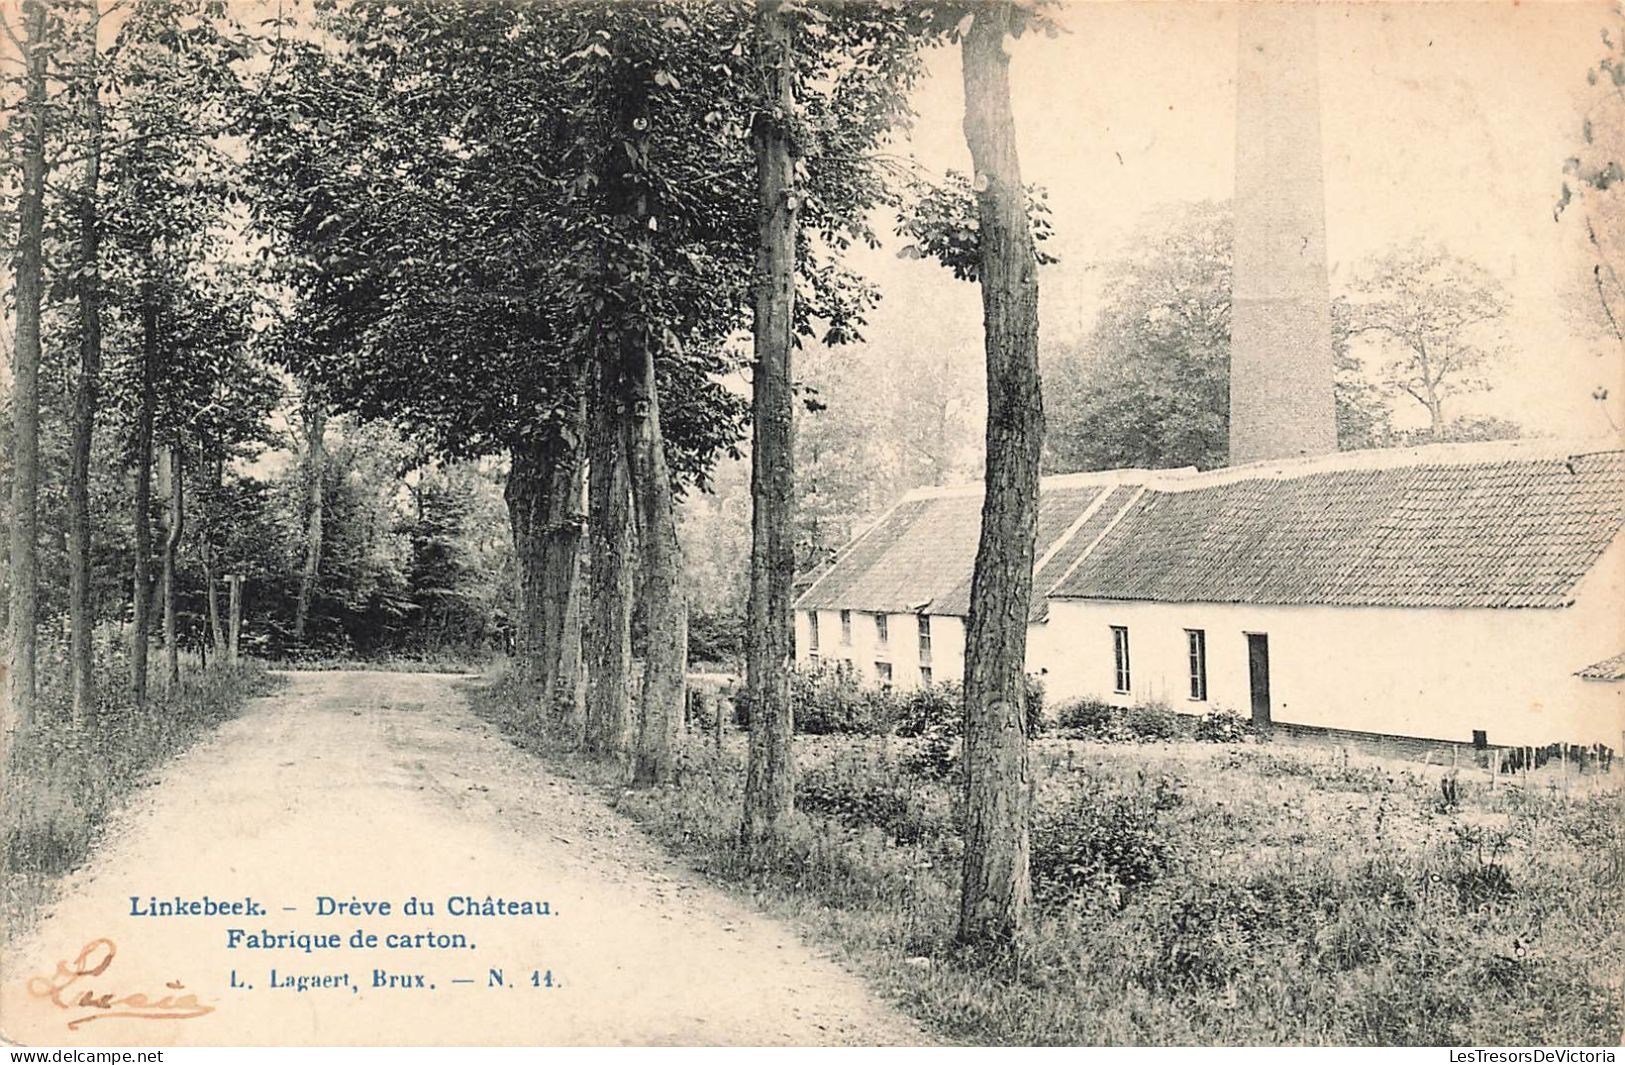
[[0, 660, 276, 940]]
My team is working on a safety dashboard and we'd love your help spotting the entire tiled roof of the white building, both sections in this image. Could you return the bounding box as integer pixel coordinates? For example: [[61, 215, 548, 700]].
[[796, 441, 1625, 619]]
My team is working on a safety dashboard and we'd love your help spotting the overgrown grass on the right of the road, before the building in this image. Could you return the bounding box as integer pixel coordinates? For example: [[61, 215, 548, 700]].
[[473, 675, 1625, 1045]]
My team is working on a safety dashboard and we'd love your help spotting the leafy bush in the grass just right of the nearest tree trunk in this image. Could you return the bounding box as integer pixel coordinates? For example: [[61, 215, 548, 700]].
[[1032, 785, 1170, 907]]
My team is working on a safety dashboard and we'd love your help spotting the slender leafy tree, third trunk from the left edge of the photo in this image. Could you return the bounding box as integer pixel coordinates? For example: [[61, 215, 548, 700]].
[[99, 0, 249, 704]]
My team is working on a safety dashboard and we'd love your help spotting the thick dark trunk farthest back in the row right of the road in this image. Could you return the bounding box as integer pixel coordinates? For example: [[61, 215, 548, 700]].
[[504, 418, 583, 722]]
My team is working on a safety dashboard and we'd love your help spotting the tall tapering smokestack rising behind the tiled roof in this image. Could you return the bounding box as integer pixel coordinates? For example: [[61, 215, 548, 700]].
[[1230, 2, 1337, 465]]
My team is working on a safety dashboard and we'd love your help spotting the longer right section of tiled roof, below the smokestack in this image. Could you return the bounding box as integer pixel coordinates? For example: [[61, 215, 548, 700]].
[[1050, 449, 1625, 606]]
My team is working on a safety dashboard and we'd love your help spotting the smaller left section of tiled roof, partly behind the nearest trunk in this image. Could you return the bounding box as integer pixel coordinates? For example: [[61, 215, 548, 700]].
[[796, 472, 1139, 616]]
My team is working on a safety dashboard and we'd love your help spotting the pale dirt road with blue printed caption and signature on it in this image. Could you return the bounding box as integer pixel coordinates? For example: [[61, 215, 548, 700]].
[[0, 673, 921, 1045]]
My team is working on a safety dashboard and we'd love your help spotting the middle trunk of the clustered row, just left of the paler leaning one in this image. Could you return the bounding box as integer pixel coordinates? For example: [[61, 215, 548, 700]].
[[585, 359, 634, 758]]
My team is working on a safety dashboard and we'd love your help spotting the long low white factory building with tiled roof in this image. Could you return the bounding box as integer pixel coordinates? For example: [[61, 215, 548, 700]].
[[796, 442, 1625, 746]]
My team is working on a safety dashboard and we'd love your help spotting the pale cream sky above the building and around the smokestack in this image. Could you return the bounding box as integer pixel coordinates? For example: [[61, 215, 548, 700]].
[[856, 0, 1625, 436]]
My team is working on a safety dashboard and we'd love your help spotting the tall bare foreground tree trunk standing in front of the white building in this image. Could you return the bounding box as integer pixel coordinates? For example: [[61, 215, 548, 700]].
[[959, 3, 1043, 948]]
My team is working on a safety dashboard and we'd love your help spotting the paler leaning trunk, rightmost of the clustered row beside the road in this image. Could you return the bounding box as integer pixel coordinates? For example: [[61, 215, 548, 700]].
[[614, 346, 689, 785]]
